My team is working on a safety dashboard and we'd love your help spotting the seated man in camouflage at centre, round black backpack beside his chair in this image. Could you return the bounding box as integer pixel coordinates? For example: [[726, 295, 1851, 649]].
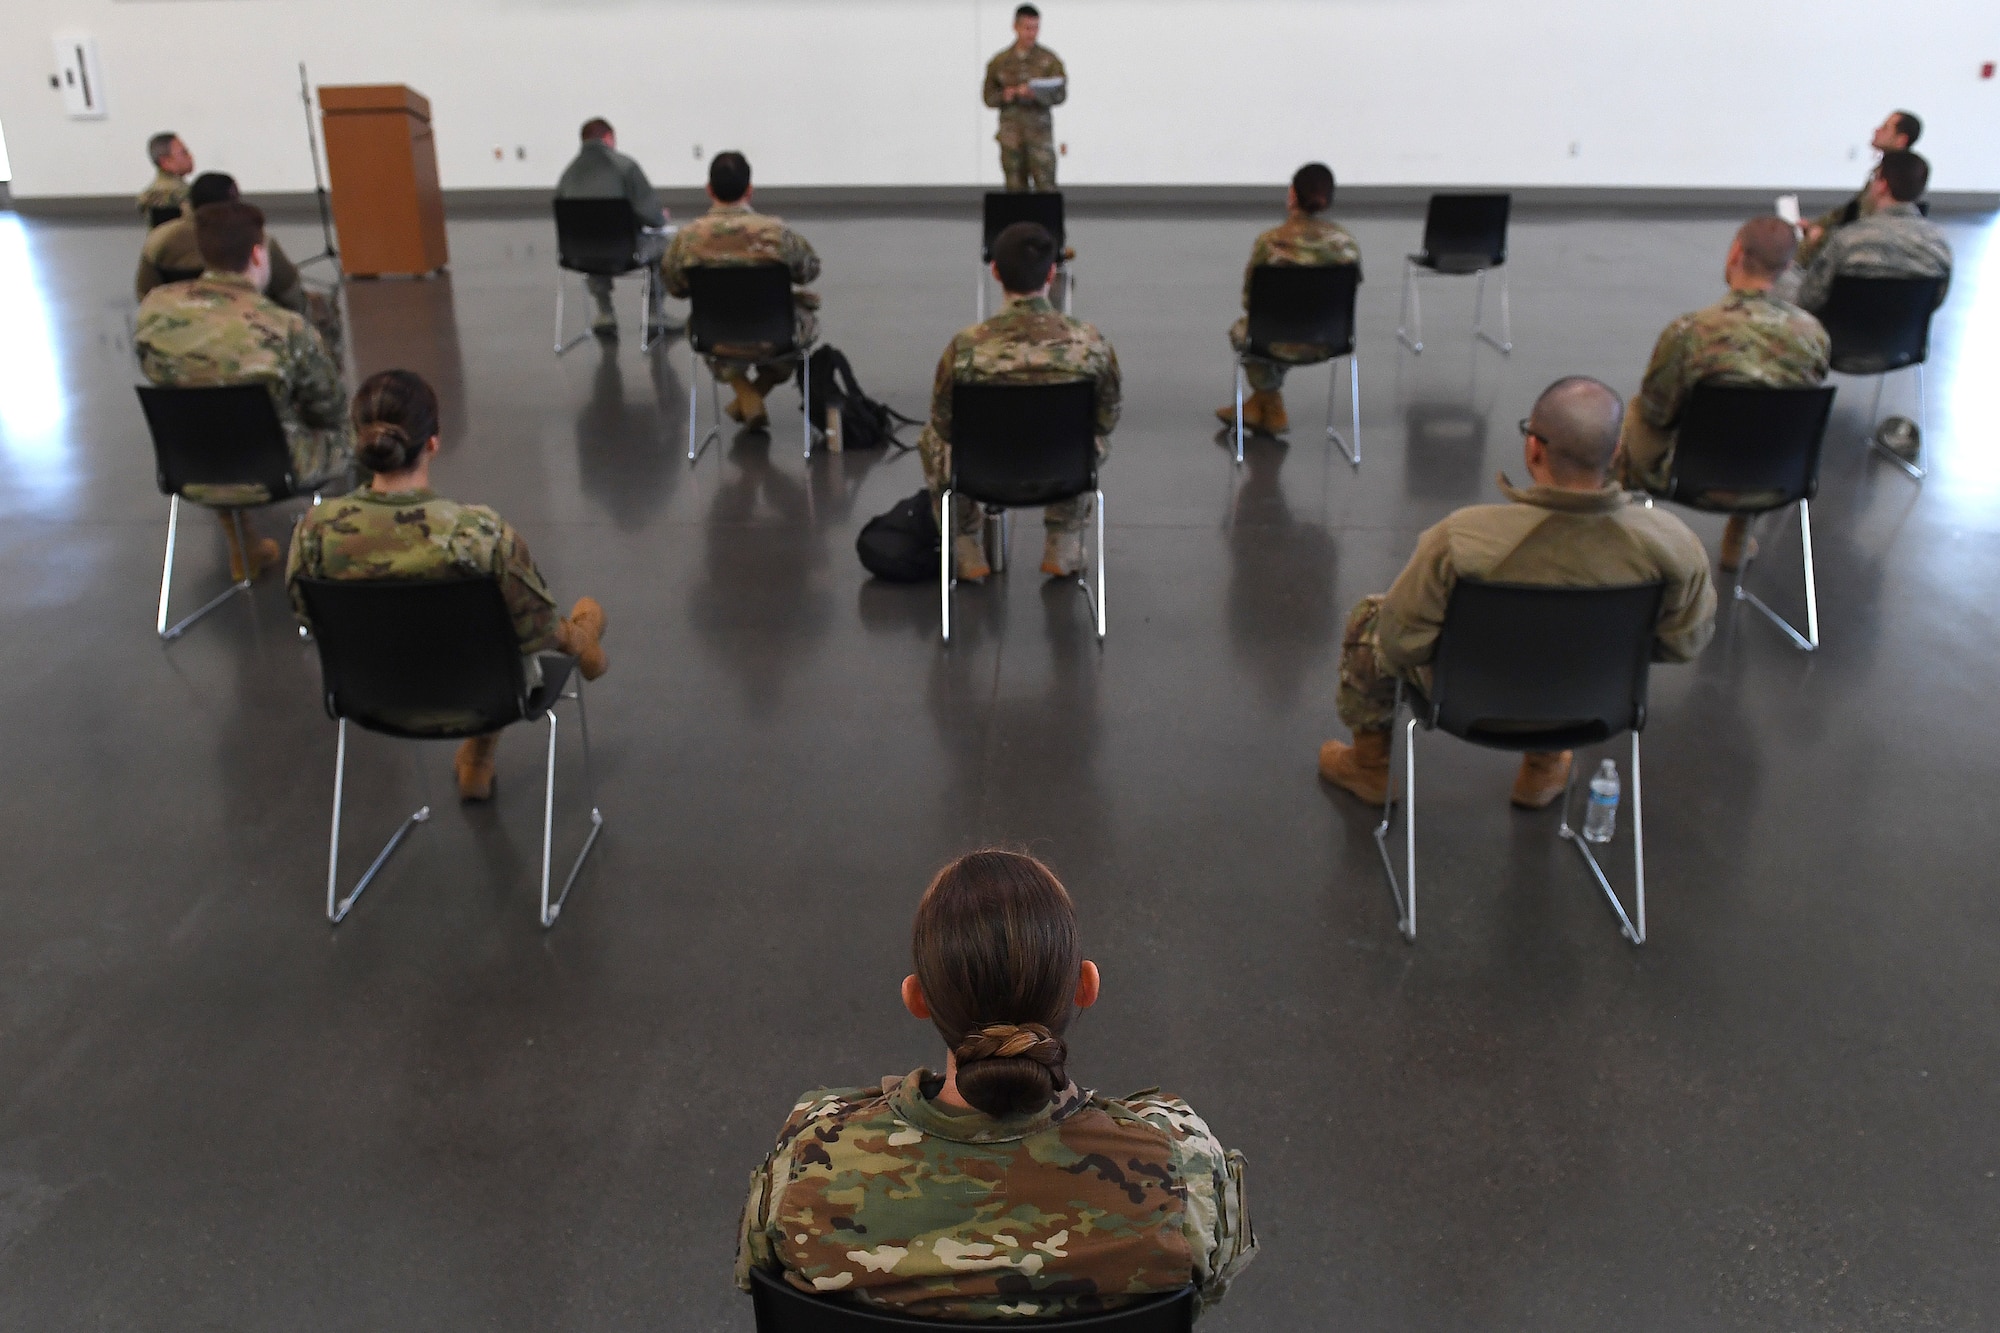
[[916, 222, 1120, 582]]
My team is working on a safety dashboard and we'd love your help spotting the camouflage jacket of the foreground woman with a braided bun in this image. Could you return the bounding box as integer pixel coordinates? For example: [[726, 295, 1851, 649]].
[[736, 1069, 1256, 1319]]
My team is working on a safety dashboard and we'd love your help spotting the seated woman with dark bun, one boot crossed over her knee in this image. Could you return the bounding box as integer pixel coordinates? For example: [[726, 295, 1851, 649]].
[[286, 370, 608, 801]]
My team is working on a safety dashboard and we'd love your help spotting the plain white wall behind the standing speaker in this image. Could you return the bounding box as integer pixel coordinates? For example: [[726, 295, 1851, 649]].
[[0, 0, 2000, 198]]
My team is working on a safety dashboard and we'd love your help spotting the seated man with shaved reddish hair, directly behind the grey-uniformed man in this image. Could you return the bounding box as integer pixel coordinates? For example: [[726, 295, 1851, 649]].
[[1612, 214, 1828, 570]]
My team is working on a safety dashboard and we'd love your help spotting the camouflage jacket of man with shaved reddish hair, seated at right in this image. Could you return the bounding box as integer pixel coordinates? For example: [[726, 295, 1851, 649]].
[[1614, 290, 1830, 492]]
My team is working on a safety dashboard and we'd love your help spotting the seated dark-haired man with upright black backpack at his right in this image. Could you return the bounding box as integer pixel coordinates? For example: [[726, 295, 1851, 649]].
[[660, 152, 820, 428]]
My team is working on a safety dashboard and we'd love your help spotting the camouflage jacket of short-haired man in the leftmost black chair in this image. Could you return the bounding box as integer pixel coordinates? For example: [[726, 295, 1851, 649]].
[[132, 272, 354, 506]]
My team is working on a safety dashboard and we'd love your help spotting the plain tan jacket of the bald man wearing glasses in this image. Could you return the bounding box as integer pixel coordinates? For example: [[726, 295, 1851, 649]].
[[1376, 476, 1716, 671]]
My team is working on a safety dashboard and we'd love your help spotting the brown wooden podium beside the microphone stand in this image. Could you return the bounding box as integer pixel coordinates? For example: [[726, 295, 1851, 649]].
[[320, 84, 450, 278]]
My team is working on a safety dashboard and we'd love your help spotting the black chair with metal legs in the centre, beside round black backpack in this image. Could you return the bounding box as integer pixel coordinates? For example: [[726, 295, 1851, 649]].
[[938, 380, 1104, 642]]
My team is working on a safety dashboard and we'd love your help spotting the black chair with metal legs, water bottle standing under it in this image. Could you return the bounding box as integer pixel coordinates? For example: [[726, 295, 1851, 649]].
[[1374, 578, 1666, 945]]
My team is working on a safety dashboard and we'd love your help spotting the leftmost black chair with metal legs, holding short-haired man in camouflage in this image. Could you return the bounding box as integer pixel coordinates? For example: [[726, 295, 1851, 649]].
[[138, 384, 318, 640]]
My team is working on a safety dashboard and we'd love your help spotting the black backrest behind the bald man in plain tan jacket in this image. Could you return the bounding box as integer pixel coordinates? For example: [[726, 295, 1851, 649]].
[[1430, 578, 1666, 751]]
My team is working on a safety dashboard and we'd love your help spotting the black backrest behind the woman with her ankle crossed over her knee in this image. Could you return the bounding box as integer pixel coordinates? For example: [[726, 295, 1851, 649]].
[[298, 578, 528, 737]]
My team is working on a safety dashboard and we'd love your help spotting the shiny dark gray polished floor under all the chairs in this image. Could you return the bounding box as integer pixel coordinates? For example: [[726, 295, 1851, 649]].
[[0, 200, 2000, 1331]]
